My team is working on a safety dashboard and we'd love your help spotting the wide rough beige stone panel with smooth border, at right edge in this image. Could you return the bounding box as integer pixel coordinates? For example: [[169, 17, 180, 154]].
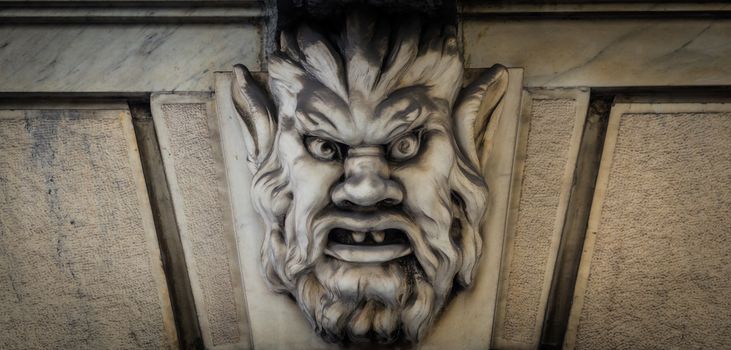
[[566, 103, 731, 349]]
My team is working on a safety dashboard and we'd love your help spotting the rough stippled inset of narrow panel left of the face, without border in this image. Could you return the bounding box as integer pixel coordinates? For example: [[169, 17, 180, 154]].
[[161, 103, 243, 345]]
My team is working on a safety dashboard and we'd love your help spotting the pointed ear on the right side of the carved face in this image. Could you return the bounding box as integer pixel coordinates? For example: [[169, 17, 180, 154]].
[[454, 64, 508, 166]]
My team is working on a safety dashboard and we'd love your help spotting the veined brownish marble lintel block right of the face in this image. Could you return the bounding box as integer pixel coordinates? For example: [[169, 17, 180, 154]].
[[462, 18, 731, 87]]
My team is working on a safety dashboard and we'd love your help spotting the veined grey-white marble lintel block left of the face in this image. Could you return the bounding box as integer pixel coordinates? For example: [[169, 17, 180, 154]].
[[0, 23, 262, 93]]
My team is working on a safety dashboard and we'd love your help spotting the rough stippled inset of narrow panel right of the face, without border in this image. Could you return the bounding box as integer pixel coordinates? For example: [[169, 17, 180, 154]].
[[503, 98, 576, 344]]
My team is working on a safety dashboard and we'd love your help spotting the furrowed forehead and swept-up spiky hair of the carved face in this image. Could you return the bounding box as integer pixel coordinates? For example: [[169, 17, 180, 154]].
[[268, 14, 463, 145]]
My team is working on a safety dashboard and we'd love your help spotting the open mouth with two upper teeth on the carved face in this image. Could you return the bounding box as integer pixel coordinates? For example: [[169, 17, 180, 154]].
[[325, 228, 412, 263]]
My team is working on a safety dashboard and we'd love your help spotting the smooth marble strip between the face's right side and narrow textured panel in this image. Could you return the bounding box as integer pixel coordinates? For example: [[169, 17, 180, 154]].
[[420, 68, 523, 350]]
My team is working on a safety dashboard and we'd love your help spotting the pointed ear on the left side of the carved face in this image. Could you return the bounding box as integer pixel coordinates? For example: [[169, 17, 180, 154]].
[[231, 64, 277, 173]]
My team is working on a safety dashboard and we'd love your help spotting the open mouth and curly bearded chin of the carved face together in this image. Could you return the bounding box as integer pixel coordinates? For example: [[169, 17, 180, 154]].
[[293, 219, 444, 344]]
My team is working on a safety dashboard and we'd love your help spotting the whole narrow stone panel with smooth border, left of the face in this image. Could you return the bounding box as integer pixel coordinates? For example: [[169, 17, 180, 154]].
[[152, 94, 249, 348]]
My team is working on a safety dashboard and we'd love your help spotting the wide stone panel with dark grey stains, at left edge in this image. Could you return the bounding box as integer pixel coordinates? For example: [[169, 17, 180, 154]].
[[0, 105, 177, 349]]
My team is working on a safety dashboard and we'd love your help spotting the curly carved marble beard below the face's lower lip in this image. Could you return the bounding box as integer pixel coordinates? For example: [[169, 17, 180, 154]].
[[297, 256, 438, 344]]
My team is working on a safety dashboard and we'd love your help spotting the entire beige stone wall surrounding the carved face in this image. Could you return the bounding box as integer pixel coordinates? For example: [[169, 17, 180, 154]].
[[0, 0, 731, 349]]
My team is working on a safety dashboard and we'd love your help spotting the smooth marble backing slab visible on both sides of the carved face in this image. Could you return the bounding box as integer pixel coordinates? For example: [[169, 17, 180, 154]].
[[216, 69, 522, 349]]
